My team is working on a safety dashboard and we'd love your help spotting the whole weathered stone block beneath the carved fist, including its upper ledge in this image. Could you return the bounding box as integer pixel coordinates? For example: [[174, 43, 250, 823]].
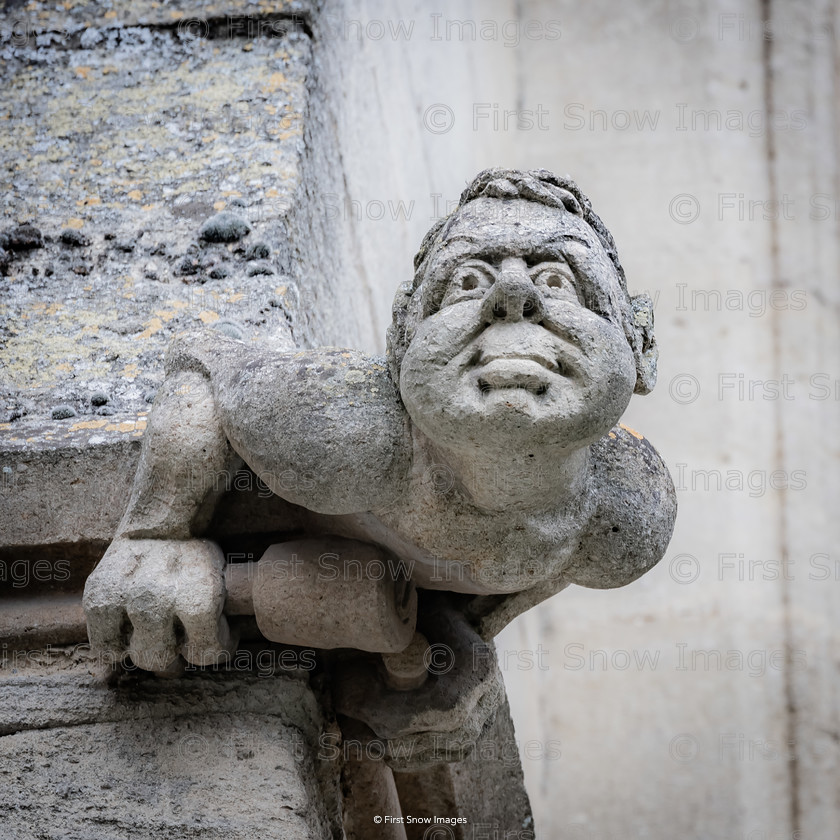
[[0, 645, 339, 840]]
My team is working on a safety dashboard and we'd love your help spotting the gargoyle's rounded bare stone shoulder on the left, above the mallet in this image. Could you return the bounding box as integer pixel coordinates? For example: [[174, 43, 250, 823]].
[[168, 334, 411, 514]]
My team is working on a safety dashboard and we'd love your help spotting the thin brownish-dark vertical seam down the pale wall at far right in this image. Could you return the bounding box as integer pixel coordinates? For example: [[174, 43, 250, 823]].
[[760, 0, 802, 837]]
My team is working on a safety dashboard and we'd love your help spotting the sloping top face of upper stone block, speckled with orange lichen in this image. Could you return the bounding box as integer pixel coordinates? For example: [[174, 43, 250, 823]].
[[0, 21, 311, 420]]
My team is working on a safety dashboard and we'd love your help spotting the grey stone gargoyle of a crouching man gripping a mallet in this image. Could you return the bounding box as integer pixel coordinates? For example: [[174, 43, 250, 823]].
[[84, 169, 676, 765]]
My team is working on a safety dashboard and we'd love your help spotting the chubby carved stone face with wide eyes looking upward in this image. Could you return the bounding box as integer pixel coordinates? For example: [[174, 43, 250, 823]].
[[400, 198, 636, 456]]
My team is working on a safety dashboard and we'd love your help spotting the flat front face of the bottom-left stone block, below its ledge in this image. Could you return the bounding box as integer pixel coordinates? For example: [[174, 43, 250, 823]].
[[0, 714, 330, 840]]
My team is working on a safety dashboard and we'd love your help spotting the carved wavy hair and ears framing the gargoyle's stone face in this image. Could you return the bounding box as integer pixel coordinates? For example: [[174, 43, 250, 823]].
[[387, 167, 657, 394]]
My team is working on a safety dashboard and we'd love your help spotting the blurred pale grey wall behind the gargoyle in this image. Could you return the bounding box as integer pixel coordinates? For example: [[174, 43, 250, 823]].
[[326, 0, 840, 840]]
